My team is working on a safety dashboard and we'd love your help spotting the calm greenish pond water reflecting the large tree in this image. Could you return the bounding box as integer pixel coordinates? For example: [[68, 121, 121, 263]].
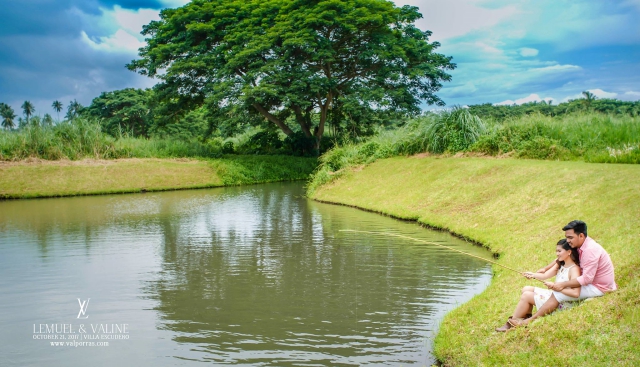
[[0, 183, 491, 366]]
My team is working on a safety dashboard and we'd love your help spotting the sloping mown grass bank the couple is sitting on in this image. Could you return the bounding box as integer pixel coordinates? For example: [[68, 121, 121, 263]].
[[313, 157, 640, 366]]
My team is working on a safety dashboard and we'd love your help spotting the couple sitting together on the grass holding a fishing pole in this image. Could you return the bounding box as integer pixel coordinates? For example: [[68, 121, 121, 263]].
[[496, 220, 617, 332]]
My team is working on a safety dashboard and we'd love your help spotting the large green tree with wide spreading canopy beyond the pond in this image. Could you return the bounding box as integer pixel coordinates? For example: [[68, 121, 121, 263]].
[[128, 0, 455, 150]]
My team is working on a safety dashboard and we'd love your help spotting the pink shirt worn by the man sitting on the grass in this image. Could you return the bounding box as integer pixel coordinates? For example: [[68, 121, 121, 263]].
[[577, 237, 618, 293]]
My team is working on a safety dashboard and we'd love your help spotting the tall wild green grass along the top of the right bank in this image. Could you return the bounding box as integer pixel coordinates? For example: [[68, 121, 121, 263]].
[[308, 108, 640, 195]]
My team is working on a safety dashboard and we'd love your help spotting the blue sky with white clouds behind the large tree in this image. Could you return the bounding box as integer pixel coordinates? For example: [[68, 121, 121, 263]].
[[0, 0, 640, 117]]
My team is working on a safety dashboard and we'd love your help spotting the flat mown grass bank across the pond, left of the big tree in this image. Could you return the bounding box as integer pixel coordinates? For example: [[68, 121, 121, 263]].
[[0, 156, 316, 199]]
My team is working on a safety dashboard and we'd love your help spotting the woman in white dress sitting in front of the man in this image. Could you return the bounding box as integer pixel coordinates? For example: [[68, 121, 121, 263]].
[[496, 239, 581, 332]]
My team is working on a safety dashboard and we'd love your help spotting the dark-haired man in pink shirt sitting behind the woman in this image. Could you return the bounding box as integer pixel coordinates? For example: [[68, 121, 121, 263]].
[[510, 220, 618, 326]]
